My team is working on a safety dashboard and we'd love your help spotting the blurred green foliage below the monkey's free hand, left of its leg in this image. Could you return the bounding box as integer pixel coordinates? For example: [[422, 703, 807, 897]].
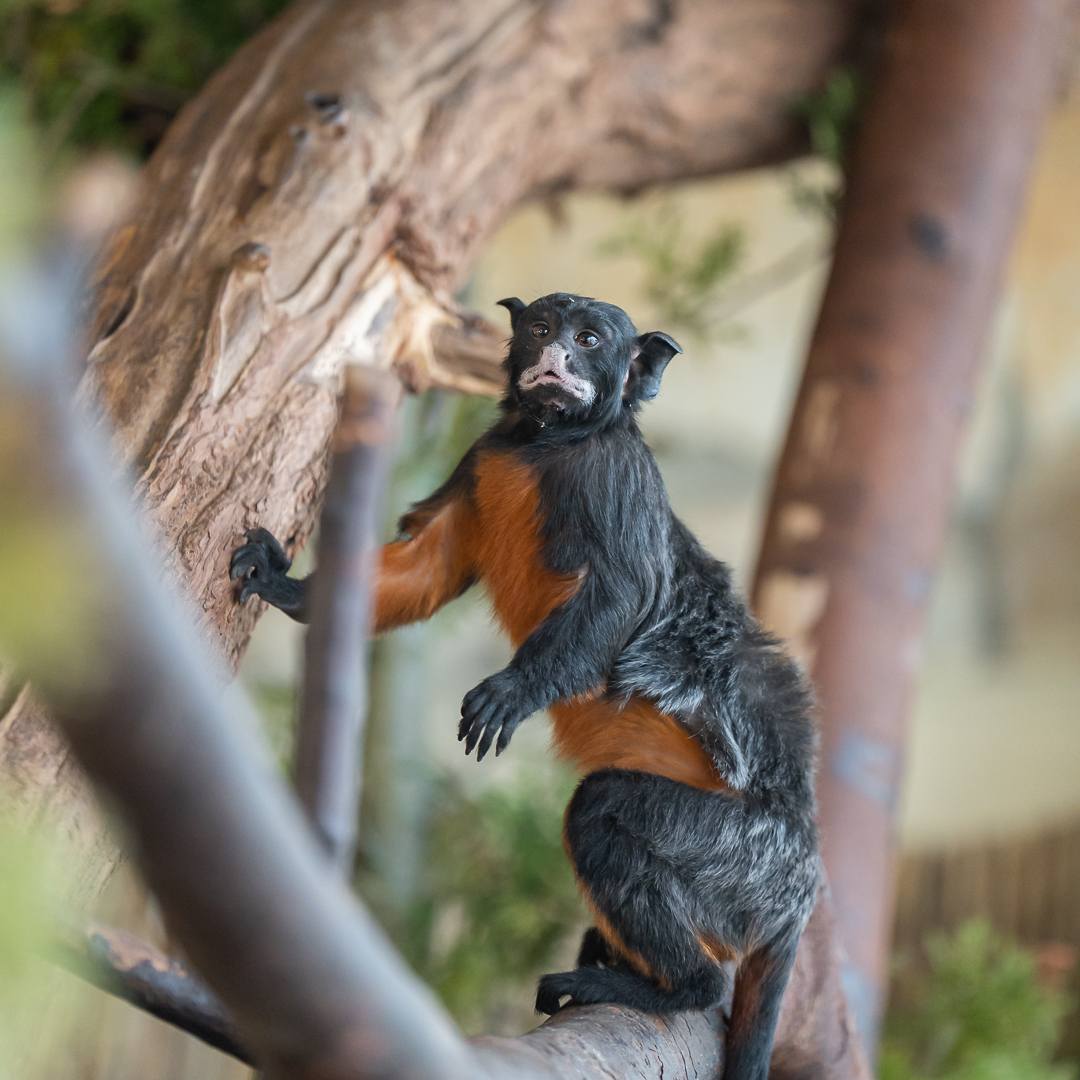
[[361, 778, 585, 1029]]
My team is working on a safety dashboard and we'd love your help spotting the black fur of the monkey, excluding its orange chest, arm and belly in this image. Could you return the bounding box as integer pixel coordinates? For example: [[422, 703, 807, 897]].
[[232, 294, 819, 1080]]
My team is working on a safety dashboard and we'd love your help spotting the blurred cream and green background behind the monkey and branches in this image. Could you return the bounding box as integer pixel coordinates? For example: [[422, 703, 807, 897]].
[[0, 0, 1080, 1080]]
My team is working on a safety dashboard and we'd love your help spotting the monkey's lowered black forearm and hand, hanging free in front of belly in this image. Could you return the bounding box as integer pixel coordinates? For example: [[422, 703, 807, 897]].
[[458, 568, 642, 760]]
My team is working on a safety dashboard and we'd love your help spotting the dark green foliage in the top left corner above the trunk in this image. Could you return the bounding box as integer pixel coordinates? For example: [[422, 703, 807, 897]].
[[0, 0, 286, 154]]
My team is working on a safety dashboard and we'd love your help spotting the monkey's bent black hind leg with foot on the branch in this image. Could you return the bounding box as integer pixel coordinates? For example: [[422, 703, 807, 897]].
[[537, 769, 737, 1013]]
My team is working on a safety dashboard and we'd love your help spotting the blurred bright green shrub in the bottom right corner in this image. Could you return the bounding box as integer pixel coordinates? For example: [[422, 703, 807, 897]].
[[880, 920, 1075, 1080]]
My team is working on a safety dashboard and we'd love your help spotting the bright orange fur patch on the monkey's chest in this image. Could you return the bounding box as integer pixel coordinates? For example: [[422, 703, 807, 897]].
[[474, 454, 582, 649]]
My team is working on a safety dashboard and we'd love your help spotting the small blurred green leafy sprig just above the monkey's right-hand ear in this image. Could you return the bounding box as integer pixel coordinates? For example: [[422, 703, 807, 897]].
[[599, 201, 745, 337]]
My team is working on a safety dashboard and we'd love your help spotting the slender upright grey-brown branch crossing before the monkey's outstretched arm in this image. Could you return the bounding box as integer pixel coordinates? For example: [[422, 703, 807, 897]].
[[296, 365, 401, 877]]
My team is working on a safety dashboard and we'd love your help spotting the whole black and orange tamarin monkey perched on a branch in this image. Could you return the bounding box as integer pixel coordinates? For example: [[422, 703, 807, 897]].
[[231, 293, 819, 1080]]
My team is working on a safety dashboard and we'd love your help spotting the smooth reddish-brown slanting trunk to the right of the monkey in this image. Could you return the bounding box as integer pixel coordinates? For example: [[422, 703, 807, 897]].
[[755, 0, 1076, 1047]]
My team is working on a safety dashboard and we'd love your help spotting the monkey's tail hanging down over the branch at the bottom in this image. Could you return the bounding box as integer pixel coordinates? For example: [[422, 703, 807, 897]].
[[724, 934, 798, 1080]]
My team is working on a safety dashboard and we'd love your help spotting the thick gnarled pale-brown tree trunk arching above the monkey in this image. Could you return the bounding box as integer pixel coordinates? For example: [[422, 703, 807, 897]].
[[0, 0, 862, 895]]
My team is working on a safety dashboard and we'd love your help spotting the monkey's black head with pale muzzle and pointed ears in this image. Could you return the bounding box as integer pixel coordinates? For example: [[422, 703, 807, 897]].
[[499, 293, 683, 427]]
